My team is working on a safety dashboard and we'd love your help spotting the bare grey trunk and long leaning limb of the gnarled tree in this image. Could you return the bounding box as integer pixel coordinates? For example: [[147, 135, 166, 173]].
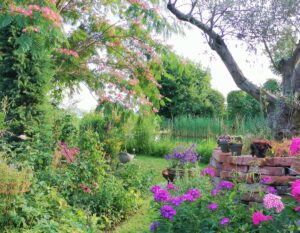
[[167, 0, 300, 139]]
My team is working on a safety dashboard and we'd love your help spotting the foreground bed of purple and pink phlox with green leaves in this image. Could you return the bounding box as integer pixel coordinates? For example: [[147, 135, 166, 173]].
[[150, 170, 300, 233]]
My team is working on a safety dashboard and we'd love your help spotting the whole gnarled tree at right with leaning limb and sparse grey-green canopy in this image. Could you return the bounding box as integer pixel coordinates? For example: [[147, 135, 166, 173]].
[[167, 0, 300, 136]]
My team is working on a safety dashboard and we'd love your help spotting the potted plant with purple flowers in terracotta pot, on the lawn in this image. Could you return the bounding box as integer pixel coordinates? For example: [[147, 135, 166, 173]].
[[162, 144, 198, 182]]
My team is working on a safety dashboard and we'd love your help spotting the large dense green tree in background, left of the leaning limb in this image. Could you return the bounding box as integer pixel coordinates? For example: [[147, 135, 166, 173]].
[[159, 51, 224, 118]]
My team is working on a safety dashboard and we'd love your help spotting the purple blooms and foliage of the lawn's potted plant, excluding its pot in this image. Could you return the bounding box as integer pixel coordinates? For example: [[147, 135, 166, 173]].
[[165, 144, 198, 168]]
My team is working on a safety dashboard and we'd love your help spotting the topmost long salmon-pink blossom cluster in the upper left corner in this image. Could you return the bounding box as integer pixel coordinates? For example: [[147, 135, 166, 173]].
[[9, 4, 62, 27]]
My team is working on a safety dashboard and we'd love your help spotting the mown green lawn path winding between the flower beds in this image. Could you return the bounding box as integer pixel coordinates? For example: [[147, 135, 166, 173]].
[[113, 155, 206, 233]]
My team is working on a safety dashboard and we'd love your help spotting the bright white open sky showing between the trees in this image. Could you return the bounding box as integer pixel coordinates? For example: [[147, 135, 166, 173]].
[[62, 24, 279, 112]]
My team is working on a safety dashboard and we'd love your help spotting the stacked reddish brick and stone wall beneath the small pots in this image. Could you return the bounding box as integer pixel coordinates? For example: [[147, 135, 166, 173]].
[[209, 148, 300, 202]]
